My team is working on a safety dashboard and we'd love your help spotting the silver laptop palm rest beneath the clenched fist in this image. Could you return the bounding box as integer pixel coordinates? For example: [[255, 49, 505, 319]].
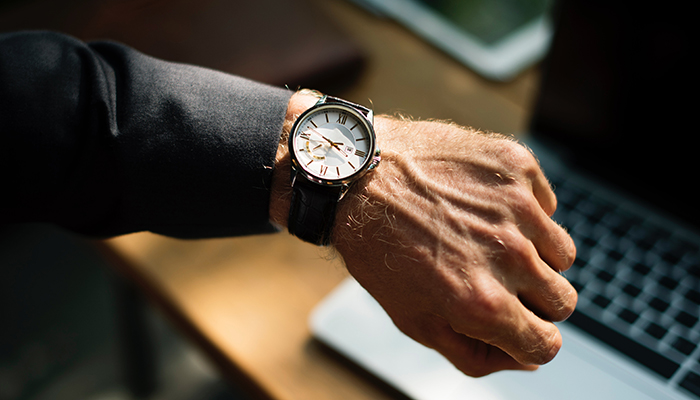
[[310, 278, 682, 400]]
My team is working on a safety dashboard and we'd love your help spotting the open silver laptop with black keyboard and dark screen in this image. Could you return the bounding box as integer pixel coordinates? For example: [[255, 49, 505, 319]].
[[310, 0, 700, 400]]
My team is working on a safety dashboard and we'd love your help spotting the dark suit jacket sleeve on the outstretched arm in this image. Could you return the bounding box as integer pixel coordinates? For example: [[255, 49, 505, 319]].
[[0, 32, 291, 237]]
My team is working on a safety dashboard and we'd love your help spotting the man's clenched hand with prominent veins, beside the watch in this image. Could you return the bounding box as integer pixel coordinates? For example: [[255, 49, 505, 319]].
[[271, 91, 577, 376]]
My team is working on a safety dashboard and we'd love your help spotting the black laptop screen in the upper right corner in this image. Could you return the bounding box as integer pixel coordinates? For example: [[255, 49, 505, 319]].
[[530, 0, 700, 228]]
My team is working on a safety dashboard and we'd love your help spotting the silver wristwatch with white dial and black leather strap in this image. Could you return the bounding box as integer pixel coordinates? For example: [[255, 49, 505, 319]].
[[287, 96, 381, 246]]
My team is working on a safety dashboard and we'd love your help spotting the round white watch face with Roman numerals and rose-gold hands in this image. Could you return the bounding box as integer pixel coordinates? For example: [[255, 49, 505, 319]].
[[290, 103, 375, 184]]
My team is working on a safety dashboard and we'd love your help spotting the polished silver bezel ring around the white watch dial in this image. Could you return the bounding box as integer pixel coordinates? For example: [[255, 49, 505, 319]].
[[288, 102, 377, 186]]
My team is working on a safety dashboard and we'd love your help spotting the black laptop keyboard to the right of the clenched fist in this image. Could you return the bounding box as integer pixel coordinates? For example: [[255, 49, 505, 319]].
[[550, 172, 700, 399]]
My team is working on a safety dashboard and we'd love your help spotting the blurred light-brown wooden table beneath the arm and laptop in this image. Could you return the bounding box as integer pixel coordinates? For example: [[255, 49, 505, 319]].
[[89, 0, 537, 400]]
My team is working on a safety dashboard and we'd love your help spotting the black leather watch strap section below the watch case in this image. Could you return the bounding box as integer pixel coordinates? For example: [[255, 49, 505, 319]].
[[287, 178, 341, 246]]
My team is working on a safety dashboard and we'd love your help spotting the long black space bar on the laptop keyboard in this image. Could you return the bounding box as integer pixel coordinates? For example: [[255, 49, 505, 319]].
[[567, 310, 680, 379]]
